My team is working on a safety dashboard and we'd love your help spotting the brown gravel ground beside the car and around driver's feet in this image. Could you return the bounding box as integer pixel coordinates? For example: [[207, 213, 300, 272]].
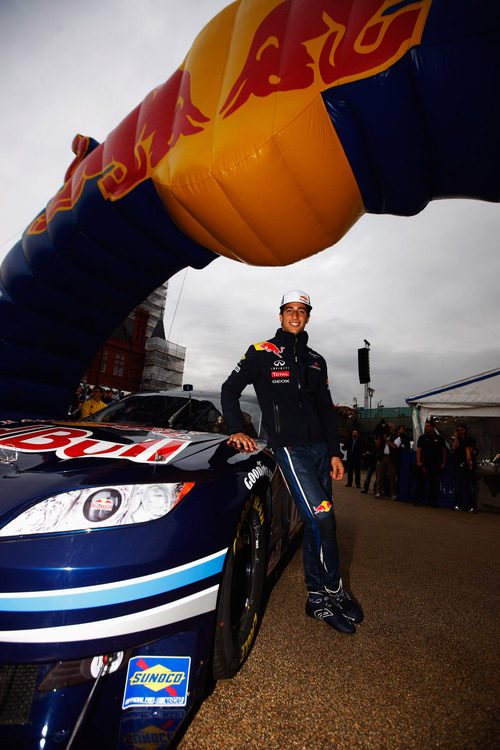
[[178, 484, 500, 750]]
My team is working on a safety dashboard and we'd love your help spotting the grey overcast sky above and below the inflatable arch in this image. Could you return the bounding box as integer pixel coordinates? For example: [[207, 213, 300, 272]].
[[0, 0, 500, 406]]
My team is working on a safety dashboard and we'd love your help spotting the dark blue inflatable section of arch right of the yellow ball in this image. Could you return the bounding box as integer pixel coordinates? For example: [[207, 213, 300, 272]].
[[323, 0, 500, 216]]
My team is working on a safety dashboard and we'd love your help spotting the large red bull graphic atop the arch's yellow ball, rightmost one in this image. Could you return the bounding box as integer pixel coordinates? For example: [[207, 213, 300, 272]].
[[221, 0, 430, 117]]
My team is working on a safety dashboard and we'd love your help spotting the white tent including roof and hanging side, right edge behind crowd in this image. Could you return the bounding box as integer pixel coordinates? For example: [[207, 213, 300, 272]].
[[406, 368, 500, 441]]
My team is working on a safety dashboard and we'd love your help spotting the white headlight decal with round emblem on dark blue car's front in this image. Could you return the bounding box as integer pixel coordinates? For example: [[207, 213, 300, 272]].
[[0, 482, 194, 536]]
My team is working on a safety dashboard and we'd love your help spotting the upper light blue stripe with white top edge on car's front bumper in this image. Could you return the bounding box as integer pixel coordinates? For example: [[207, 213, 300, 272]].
[[0, 549, 226, 612]]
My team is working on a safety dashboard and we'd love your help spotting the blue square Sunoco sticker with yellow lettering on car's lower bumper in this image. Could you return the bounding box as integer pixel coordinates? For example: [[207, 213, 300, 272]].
[[122, 656, 191, 708]]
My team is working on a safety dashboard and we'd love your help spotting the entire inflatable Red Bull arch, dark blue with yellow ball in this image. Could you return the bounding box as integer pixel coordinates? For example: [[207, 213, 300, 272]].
[[0, 0, 500, 418]]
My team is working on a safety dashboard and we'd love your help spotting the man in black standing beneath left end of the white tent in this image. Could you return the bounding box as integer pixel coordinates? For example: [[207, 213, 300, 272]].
[[415, 420, 446, 508]]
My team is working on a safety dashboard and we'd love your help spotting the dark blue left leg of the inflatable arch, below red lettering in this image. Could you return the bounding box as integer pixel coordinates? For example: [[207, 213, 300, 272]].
[[0, 181, 217, 419]]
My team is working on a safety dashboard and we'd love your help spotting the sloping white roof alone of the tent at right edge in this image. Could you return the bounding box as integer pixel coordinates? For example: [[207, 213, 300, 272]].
[[406, 368, 500, 413]]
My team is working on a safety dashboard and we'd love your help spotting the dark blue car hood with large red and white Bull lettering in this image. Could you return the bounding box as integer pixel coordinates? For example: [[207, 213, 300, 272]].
[[0, 421, 263, 522]]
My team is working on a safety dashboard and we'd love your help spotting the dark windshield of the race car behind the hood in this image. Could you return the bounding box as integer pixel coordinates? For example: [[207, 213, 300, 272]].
[[85, 394, 225, 433]]
